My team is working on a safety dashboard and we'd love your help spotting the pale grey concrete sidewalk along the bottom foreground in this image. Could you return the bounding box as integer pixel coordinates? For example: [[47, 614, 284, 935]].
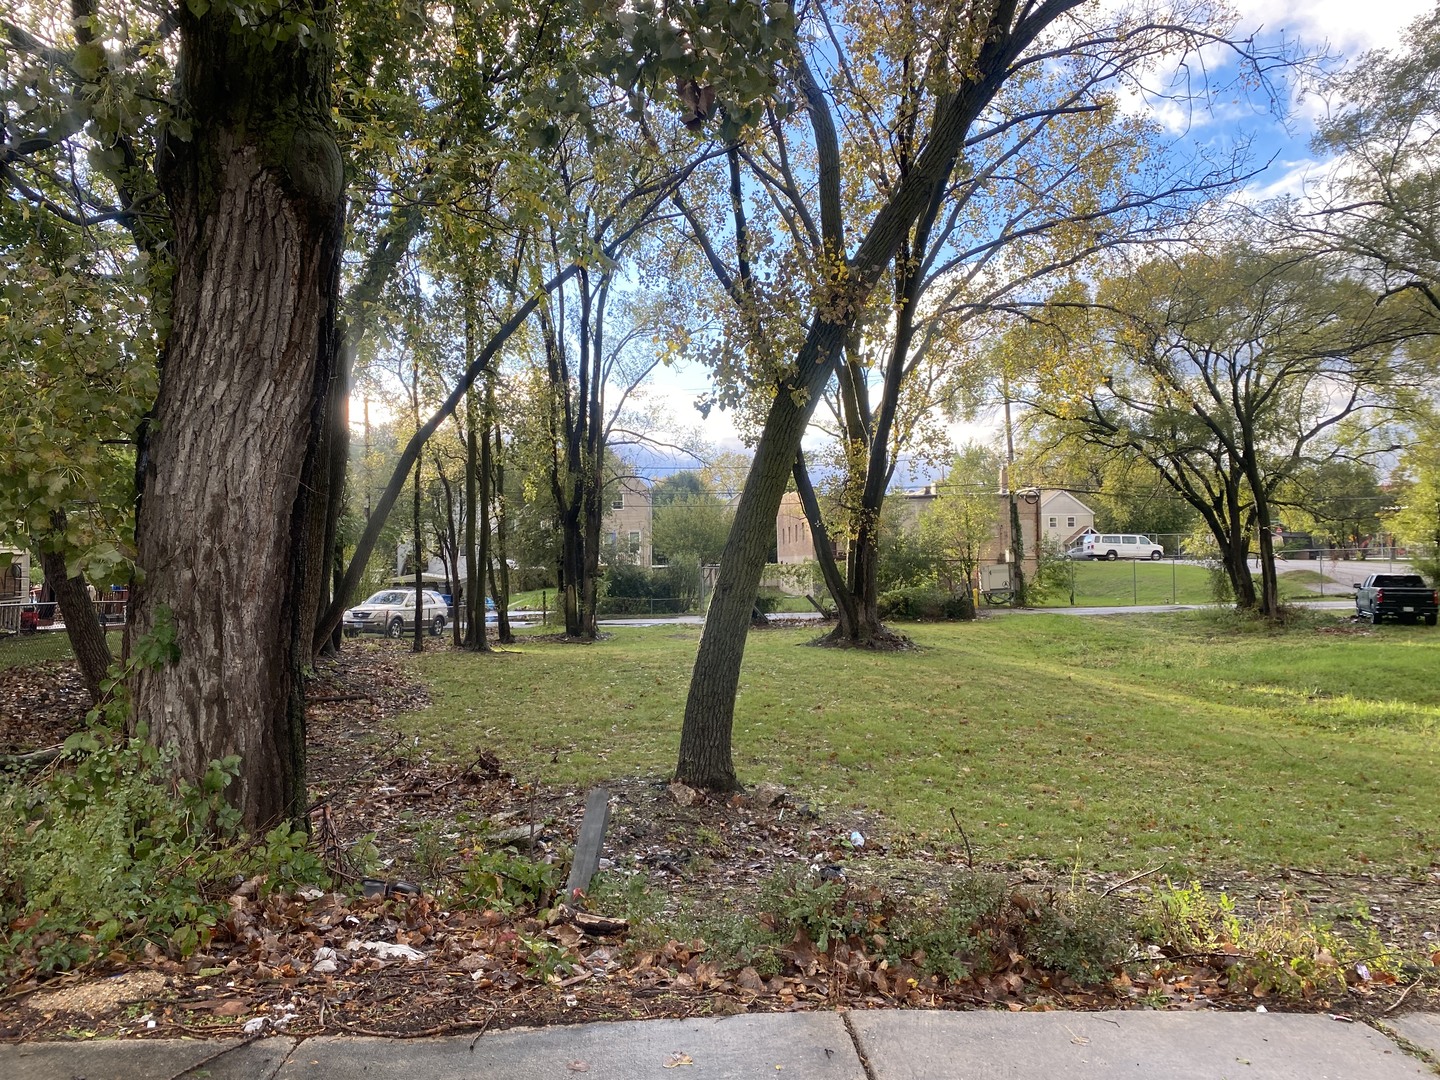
[[0, 1009, 1440, 1080]]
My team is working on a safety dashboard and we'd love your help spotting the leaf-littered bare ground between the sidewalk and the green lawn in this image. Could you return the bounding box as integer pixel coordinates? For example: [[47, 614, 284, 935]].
[[0, 647, 1440, 1040]]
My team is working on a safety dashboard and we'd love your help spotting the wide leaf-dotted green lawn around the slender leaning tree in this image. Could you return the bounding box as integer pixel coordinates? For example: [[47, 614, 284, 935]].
[[399, 610, 1440, 873]]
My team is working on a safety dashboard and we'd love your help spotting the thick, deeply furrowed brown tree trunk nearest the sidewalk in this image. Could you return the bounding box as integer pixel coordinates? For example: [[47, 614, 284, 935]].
[[130, 0, 344, 829]]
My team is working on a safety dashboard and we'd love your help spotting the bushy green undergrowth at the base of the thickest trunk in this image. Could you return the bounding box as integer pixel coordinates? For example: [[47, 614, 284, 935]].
[[0, 726, 328, 978]]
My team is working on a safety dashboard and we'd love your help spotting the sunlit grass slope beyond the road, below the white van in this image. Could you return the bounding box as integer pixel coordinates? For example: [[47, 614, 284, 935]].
[[1040, 559, 1336, 608]]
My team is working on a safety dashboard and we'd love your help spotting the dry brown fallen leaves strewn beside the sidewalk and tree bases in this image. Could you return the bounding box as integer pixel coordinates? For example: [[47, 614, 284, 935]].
[[0, 647, 1440, 1042]]
